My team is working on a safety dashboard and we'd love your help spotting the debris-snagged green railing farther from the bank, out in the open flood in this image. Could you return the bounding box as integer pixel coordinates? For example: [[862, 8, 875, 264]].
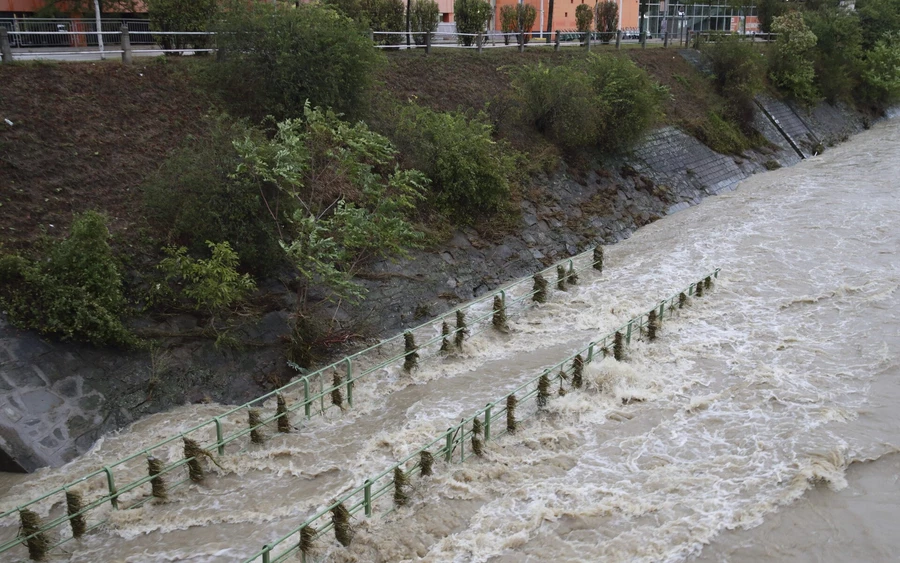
[[244, 268, 720, 563]]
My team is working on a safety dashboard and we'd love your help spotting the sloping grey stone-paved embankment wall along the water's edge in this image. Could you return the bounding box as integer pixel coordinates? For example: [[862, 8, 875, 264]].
[[0, 96, 876, 470]]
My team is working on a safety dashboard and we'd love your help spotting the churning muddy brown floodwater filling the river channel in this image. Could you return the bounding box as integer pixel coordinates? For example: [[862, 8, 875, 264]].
[[0, 119, 900, 563]]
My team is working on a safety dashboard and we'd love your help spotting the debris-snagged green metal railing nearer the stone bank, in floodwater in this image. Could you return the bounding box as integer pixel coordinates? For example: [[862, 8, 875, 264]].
[[0, 247, 603, 554]]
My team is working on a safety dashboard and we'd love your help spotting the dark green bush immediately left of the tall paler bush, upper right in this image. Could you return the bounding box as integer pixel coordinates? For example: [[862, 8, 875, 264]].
[[703, 35, 766, 127]]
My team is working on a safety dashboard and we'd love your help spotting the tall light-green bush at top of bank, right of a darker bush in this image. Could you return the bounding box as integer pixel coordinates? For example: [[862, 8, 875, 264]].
[[769, 12, 819, 104]]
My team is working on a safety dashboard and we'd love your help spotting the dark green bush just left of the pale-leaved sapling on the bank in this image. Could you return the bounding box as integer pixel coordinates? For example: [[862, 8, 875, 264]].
[[143, 117, 290, 275]]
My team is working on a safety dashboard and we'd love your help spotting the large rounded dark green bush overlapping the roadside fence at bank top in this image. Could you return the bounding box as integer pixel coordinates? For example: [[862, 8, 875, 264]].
[[209, 0, 383, 119]]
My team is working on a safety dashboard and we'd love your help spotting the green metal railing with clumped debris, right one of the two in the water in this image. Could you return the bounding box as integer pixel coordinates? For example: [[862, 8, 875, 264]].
[[245, 269, 719, 563]]
